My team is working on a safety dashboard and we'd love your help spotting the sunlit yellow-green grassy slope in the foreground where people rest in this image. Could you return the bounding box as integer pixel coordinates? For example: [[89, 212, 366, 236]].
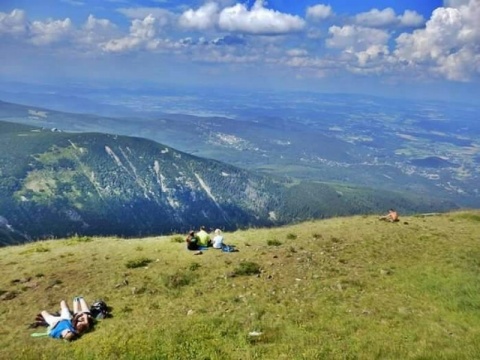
[[0, 212, 480, 359]]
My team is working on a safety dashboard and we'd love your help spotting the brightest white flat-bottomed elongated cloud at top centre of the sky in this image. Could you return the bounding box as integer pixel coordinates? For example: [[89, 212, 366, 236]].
[[218, 0, 305, 35]]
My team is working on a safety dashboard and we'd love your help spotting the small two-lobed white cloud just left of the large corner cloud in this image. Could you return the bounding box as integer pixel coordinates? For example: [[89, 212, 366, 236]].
[[355, 8, 425, 27]]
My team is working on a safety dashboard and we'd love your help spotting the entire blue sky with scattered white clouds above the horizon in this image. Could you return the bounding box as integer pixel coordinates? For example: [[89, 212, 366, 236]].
[[0, 0, 480, 102]]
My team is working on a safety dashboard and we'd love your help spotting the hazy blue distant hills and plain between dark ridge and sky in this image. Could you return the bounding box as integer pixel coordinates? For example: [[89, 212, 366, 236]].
[[0, 87, 480, 208]]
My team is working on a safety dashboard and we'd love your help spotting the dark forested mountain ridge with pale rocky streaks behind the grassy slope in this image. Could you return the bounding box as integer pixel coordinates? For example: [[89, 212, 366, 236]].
[[0, 119, 456, 245]]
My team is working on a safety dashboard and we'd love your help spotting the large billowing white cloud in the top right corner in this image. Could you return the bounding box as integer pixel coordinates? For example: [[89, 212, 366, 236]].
[[395, 0, 480, 81]]
